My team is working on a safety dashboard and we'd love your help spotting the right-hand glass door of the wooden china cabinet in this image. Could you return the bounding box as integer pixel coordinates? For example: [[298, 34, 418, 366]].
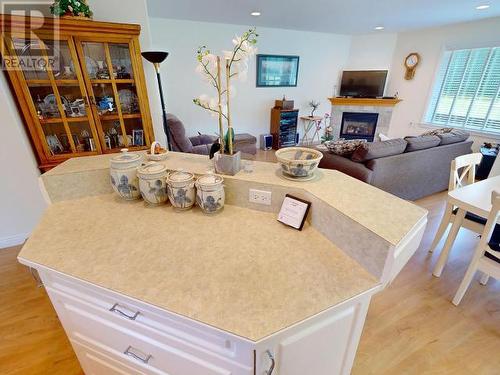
[[78, 40, 150, 152]]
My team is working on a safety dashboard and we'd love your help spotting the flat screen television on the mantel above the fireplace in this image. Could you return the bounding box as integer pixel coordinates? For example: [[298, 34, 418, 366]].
[[340, 70, 387, 98]]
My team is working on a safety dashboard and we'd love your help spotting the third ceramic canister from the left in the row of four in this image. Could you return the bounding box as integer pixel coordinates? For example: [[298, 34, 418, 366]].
[[167, 171, 196, 210]]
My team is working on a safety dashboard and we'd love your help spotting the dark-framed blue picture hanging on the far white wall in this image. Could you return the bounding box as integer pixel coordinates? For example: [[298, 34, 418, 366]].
[[256, 55, 299, 87]]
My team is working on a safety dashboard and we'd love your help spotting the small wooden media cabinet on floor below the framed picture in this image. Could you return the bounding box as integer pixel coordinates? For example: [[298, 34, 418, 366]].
[[271, 108, 299, 150]]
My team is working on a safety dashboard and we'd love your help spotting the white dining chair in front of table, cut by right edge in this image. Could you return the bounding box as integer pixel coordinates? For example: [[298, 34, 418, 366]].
[[453, 191, 500, 306]]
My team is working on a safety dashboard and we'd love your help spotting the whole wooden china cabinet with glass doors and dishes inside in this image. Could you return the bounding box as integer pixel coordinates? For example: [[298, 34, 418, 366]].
[[0, 16, 154, 171]]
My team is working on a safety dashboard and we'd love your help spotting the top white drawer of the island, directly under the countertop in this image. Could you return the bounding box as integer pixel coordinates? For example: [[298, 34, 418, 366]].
[[42, 273, 253, 366]]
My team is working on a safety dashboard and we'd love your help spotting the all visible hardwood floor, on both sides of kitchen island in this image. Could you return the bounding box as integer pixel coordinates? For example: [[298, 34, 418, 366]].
[[0, 192, 500, 375]]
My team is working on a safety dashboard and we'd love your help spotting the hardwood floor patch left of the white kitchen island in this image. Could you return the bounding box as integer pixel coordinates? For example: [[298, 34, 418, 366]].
[[0, 246, 83, 375]]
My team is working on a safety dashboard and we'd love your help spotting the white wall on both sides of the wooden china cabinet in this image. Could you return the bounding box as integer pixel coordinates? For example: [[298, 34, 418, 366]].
[[0, 0, 161, 248]]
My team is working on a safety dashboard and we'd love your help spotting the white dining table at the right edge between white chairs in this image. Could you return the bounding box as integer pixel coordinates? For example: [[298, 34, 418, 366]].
[[432, 176, 500, 277]]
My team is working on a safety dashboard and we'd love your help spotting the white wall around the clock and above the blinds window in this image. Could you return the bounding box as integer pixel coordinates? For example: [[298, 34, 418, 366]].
[[388, 18, 500, 149]]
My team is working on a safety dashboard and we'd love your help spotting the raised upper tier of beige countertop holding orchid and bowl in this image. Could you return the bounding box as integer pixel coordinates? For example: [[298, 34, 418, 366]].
[[44, 152, 427, 246]]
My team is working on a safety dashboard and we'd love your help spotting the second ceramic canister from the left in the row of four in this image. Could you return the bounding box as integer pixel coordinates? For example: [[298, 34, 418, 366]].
[[137, 161, 167, 204]]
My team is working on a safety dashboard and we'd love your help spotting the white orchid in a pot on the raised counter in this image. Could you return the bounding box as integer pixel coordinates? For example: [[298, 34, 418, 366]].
[[193, 28, 258, 175]]
